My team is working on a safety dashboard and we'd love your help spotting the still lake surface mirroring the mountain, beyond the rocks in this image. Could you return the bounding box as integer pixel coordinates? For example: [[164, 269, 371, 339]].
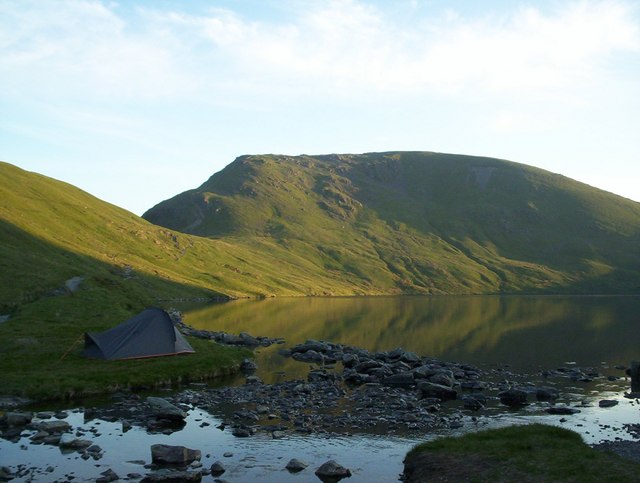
[[185, 296, 640, 371]]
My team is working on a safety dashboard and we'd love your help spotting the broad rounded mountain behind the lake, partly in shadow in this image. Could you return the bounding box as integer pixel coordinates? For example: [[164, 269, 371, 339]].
[[143, 152, 640, 294]]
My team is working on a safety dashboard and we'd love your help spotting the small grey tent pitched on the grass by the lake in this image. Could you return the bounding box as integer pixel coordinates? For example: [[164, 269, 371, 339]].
[[84, 308, 195, 359]]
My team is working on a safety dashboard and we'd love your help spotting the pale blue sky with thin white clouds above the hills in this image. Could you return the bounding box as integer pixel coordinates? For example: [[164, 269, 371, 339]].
[[0, 0, 640, 215]]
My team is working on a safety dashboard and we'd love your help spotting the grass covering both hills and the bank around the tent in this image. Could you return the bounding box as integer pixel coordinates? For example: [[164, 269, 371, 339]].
[[0, 152, 640, 398]]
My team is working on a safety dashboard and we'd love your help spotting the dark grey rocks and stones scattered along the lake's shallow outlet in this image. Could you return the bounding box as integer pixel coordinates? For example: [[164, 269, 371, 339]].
[[0, 314, 638, 481]]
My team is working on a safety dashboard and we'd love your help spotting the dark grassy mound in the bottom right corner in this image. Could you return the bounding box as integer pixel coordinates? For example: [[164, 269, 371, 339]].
[[405, 424, 640, 482]]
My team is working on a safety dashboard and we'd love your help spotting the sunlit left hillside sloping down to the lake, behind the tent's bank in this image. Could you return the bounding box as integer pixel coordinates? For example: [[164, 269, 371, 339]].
[[0, 162, 392, 310]]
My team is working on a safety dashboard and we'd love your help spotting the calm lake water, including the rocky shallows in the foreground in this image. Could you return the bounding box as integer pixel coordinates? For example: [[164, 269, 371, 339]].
[[5, 296, 640, 482]]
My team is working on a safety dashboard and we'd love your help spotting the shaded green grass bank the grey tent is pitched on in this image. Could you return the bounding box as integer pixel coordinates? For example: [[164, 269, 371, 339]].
[[0, 281, 251, 400]]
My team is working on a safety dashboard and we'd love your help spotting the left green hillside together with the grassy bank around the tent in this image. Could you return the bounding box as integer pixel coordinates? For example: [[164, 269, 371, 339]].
[[0, 163, 364, 398]]
